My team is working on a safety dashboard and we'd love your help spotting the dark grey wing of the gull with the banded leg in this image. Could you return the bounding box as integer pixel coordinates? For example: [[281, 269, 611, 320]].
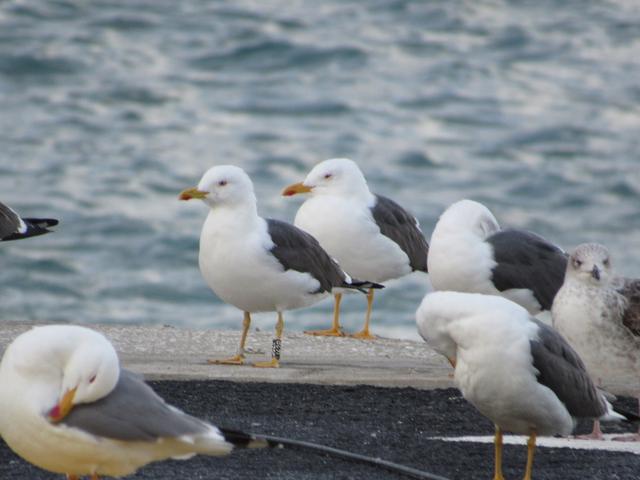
[[267, 218, 348, 293]]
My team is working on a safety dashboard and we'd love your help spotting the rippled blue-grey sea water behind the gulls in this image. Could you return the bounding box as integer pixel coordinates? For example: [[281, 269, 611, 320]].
[[0, 0, 640, 338]]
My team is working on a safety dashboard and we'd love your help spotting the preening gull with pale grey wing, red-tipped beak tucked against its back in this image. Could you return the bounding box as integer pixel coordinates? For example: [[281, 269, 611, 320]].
[[0, 325, 276, 480]]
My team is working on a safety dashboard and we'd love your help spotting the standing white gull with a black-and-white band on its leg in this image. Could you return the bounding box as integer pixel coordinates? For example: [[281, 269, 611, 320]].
[[180, 165, 382, 367]]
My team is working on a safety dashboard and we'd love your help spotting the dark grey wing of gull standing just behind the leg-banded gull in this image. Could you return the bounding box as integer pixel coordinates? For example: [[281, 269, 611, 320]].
[[371, 195, 429, 272]]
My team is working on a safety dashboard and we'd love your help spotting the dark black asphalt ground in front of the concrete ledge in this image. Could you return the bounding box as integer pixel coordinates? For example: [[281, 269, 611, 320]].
[[0, 381, 640, 480]]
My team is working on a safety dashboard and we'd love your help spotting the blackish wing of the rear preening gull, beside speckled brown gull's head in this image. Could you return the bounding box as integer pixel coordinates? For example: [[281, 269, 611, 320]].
[[486, 229, 567, 310]]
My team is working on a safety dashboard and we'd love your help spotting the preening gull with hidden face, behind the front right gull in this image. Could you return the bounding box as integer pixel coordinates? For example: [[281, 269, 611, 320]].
[[428, 199, 567, 315]]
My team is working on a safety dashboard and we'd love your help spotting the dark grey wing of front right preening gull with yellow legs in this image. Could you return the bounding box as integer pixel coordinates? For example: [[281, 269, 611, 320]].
[[530, 318, 606, 418]]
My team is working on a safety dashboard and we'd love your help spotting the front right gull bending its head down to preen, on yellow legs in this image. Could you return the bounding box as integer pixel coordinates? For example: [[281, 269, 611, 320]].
[[416, 292, 640, 480]]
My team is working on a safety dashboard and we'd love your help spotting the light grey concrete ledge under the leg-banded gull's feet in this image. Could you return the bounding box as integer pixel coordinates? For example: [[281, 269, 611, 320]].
[[0, 322, 453, 389]]
